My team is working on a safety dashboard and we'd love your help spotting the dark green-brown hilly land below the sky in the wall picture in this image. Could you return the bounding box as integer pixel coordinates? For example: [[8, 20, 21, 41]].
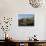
[[18, 18, 34, 26]]
